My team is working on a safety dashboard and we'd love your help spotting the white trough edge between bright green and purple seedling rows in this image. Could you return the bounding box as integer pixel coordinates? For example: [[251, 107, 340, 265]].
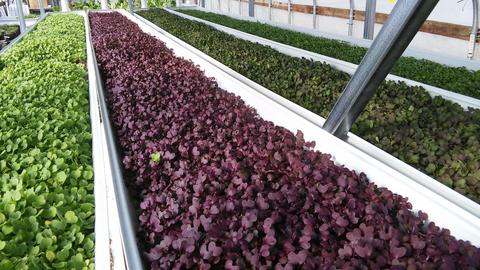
[[83, 11, 126, 270]]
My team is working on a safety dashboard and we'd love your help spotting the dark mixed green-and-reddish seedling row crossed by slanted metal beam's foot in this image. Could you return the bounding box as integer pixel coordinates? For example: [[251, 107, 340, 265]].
[[139, 10, 480, 202]]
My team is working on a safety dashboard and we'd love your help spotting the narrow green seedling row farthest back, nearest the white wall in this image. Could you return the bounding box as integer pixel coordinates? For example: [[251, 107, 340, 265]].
[[178, 10, 480, 98]]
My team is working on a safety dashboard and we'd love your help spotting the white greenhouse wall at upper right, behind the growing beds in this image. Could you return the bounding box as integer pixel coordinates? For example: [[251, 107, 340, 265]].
[[196, 0, 480, 60]]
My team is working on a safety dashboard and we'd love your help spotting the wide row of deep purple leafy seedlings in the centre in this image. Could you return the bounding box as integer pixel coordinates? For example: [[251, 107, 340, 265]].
[[90, 13, 480, 269]]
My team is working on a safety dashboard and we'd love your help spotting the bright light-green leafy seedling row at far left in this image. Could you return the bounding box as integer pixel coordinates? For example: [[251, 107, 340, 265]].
[[0, 15, 95, 269]]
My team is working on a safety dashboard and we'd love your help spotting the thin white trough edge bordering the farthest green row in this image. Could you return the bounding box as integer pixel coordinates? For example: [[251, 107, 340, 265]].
[[165, 8, 480, 109]]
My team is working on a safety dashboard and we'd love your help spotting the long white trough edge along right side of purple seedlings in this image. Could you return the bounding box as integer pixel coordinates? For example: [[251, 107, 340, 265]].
[[119, 10, 480, 246]]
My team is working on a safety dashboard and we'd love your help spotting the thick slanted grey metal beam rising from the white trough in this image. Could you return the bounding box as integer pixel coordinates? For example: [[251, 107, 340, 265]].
[[323, 0, 439, 138]]
